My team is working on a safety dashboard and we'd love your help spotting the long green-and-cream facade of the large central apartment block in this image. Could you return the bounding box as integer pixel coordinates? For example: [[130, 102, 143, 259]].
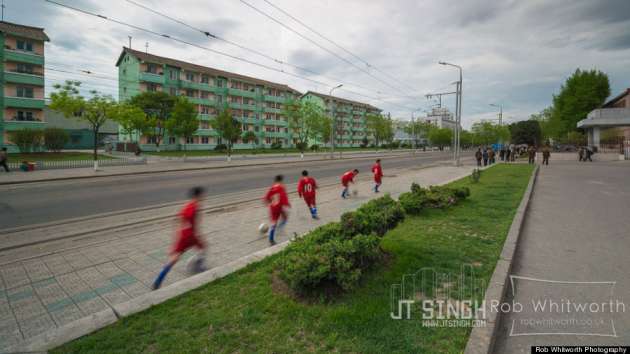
[[116, 48, 308, 150]]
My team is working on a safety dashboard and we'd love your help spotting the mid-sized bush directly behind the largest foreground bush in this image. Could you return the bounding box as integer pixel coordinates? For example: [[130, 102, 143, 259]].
[[341, 195, 405, 236]]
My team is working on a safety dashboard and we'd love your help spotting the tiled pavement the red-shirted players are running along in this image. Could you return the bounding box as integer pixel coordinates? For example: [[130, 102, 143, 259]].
[[0, 162, 472, 351]]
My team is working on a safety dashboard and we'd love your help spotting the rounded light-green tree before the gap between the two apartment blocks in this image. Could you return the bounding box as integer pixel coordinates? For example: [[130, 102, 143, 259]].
[[283, 100, 324, 158]]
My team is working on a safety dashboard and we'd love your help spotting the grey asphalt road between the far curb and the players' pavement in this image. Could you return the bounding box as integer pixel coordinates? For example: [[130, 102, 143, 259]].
[[0, 152, 450, 229]]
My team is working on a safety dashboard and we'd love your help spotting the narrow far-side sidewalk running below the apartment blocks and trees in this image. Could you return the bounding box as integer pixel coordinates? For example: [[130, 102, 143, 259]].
[[0, 151, 432, 185]]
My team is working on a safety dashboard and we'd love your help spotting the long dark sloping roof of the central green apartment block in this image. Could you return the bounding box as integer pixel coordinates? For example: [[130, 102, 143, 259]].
[[116, 47, 300, 94]]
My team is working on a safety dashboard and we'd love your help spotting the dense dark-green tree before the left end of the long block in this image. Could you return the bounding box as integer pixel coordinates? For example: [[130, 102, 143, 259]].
[[129, 91, 177, 151]]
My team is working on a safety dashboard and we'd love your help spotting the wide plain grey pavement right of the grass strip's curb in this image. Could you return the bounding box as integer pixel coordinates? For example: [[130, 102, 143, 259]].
[[495, 160, 630, 353]]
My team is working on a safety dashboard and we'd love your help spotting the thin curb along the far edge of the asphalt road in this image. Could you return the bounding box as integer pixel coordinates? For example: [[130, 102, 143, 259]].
[[0, 153, 422, 186]]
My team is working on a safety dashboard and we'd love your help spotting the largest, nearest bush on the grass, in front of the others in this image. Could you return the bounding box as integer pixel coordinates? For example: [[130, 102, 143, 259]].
[[279, 235, 381, 294]]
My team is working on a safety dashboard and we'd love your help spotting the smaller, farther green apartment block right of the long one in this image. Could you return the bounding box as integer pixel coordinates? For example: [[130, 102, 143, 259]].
[[301, 91, 381, 147]]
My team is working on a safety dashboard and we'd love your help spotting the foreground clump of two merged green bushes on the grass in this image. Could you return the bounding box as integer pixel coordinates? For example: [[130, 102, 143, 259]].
[[277, 195, 405, 294]]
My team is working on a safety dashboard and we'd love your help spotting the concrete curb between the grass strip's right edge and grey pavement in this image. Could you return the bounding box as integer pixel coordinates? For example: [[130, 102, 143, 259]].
[[464, 165, 540, 354]]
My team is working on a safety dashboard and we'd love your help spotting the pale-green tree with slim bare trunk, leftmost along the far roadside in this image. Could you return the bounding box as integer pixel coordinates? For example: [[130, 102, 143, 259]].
[[50, 80, 117, 170]]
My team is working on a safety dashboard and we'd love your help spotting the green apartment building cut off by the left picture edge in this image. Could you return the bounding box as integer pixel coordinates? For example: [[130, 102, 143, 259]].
[[0, 21, 49, 151]]
